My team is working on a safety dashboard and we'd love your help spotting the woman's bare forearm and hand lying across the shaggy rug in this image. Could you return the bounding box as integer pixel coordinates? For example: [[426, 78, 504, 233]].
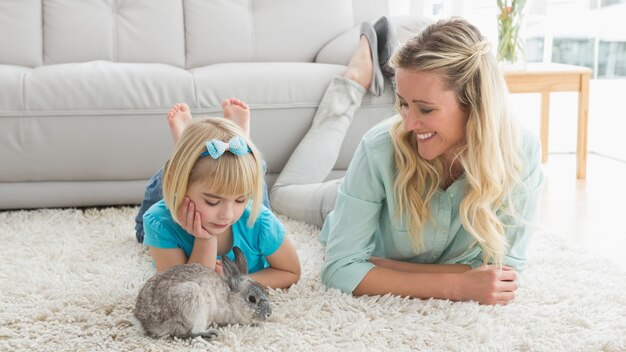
[[353, 264, 517, 304]]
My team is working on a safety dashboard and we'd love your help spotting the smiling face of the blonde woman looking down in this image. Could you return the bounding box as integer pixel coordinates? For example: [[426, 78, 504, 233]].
[[396, 68, 468, 165]]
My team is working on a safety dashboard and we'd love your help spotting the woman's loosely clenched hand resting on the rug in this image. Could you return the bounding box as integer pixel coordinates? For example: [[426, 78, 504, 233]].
[[458, 265, 517, 305]]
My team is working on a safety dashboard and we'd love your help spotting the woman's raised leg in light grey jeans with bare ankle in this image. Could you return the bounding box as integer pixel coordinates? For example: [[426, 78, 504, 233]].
[[270, 36, 376, 227]]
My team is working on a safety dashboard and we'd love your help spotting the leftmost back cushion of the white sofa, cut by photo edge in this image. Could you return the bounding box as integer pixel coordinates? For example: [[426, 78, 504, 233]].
[[0, 0, 42, 67]]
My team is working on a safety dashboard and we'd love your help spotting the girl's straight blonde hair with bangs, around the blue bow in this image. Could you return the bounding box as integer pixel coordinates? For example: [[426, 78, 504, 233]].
[[163, 117, 263, 226]]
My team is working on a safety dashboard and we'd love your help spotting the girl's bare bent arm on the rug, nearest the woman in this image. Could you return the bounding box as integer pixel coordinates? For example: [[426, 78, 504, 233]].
[[250, 237, 300, 288]]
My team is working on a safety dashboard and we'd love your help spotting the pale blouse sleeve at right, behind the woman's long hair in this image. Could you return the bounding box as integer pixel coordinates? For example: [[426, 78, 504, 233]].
[[504, 134, 543, 272]]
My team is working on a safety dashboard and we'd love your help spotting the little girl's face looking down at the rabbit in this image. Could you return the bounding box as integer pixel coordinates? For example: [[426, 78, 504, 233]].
[[187, 182, 250, 235]]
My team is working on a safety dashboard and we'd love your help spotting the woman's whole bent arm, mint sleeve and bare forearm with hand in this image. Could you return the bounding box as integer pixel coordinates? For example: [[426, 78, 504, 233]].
[[320, 129, 517, 304]]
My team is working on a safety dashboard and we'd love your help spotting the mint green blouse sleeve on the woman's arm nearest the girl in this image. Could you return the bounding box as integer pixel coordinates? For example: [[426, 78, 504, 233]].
[[320, 136, 385, 293]]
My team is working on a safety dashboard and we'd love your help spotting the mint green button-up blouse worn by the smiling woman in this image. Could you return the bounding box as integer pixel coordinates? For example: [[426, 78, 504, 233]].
[[319, 116, 543, 293]]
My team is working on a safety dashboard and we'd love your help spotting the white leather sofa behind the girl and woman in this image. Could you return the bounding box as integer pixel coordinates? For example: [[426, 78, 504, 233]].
[[0, 0, 426, 209]]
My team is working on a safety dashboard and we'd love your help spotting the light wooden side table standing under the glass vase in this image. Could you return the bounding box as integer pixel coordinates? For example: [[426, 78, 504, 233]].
[[504, 63, 591, 179]]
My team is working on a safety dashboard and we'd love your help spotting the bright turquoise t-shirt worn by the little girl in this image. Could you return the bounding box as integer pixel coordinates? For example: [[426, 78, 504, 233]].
[[143, 200, 285, 273]]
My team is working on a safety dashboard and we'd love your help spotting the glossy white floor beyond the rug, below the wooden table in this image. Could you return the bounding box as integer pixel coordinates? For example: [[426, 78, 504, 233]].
[[538, 153, 626, 269]]
